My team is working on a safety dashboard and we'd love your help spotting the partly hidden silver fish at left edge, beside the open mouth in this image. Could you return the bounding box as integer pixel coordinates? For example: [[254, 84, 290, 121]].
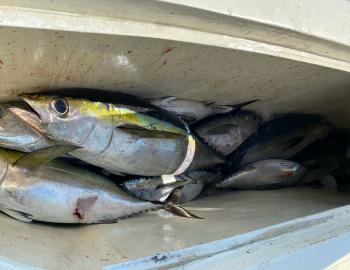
[[0, 103, 52, 152]]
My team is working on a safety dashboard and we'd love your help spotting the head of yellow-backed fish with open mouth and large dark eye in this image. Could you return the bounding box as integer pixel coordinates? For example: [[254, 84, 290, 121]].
[[10, 95, 101, 146]]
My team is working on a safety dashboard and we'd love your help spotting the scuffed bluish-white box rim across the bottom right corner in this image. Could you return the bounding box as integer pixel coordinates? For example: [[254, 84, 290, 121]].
[[104, 206, 350, 270]]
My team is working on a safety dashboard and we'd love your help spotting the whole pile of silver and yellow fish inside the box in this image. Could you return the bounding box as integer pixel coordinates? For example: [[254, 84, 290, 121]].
[[0, 89, 349, 223]]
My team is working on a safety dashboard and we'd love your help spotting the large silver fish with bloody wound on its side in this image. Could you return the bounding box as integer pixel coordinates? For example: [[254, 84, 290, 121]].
[[0, 146, 159, 223]]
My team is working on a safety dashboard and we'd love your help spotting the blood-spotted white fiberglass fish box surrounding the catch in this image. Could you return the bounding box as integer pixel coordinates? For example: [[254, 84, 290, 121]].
[[0, 0, 350, 269]]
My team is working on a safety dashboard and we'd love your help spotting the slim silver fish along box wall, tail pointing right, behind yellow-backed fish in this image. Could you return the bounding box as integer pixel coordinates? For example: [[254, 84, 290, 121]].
[[150, 97, 256, 123]]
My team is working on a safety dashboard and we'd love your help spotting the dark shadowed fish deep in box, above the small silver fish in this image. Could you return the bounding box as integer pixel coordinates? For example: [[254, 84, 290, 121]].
[[227, 113, 332, 172]]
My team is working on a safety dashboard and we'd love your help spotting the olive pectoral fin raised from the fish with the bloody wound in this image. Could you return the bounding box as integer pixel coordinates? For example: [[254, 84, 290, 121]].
[[13, 145, 79, 170]]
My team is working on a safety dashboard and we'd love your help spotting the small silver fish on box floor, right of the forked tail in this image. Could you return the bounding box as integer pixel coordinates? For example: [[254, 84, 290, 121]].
[[216, 159, 306, 189]]
